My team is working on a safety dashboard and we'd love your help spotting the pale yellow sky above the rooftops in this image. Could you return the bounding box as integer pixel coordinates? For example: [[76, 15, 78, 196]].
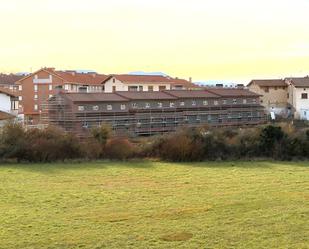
[[0, 0, 309, 83]]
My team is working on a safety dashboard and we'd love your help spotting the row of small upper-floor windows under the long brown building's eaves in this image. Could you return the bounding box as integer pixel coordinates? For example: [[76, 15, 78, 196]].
[[78, 99, 256, 111]]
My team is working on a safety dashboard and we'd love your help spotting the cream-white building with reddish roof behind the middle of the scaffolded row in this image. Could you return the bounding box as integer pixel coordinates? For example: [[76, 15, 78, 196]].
[[103, 74, 198, 93]]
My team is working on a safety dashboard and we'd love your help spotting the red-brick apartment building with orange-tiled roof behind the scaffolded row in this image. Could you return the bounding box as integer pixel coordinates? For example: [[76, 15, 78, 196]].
[[16, 68, 107, 124]]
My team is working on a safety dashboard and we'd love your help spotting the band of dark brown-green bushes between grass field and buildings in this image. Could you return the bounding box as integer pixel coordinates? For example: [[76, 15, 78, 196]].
[[0, 123, 309, 162]]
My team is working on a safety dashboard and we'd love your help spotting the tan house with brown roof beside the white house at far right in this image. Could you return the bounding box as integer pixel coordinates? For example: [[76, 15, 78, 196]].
[[247, 79, 289, 117]]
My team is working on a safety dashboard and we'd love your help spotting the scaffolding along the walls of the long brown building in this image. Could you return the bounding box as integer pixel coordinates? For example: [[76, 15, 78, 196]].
[[42, 95, 266, 137]]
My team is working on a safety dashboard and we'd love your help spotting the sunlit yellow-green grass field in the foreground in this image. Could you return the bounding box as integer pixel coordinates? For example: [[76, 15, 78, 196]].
[[0, 162, 309, 249]]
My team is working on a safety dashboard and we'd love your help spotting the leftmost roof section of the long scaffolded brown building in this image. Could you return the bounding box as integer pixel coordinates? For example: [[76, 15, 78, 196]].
[[62, 93, 128, 102]]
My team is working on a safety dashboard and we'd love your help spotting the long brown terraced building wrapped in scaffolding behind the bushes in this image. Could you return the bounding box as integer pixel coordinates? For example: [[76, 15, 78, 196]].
[[45, 89, 265, 136]]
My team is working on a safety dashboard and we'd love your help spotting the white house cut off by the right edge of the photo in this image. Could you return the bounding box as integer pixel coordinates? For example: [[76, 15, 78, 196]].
[[285, 76, 309, 120]]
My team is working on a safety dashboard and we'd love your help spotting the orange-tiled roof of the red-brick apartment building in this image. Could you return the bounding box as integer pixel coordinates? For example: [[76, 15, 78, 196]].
[[19, 68, 109, 85]]
